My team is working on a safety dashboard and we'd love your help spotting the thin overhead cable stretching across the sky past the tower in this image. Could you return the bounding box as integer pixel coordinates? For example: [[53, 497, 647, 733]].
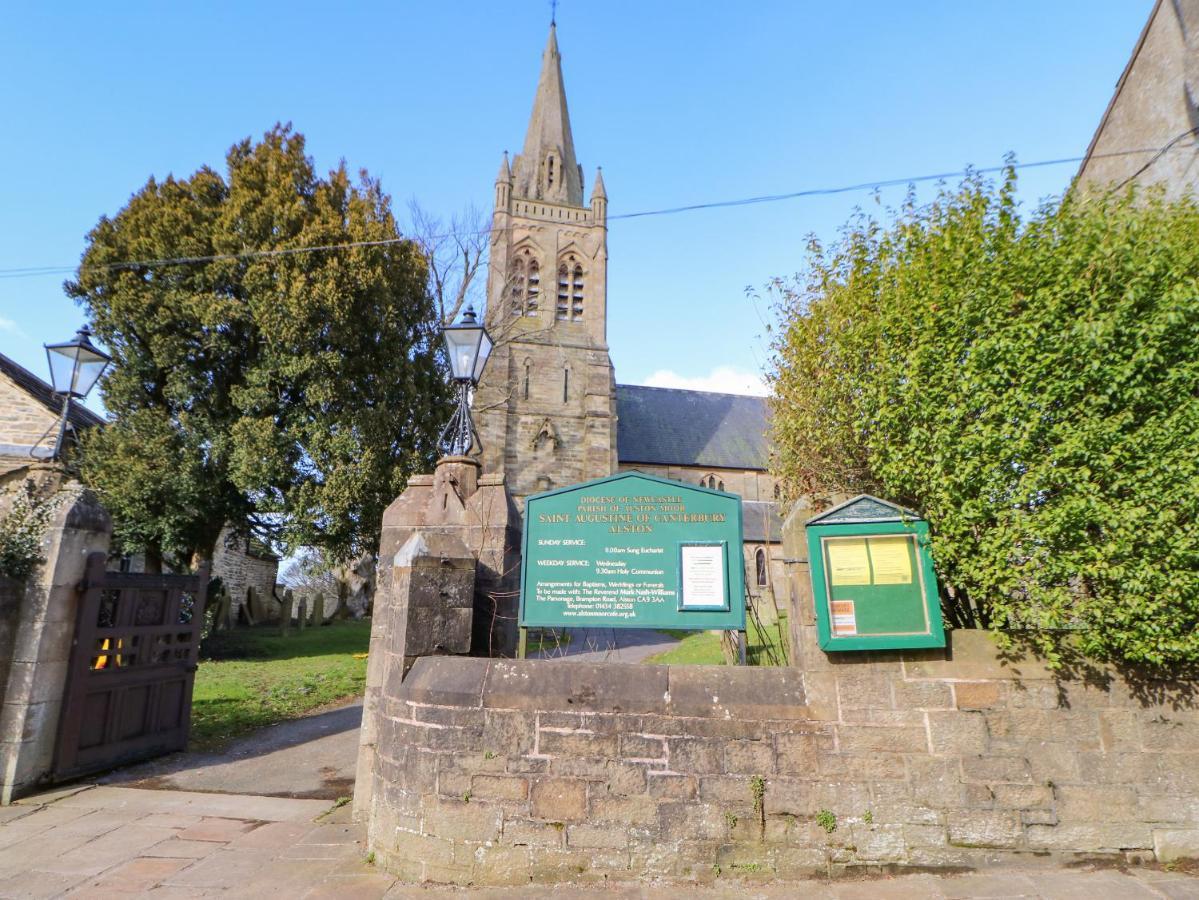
[[0, 128, 1199, 278]]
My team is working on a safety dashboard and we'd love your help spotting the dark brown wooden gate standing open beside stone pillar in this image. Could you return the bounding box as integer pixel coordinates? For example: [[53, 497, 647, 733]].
[[54, 554, 209, 780]]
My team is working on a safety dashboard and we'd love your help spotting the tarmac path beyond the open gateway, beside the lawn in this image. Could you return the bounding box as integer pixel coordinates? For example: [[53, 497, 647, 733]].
[[98, 700, 362, 801]]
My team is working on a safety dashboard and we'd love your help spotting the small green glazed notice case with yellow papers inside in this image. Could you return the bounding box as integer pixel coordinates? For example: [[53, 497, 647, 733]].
[[806, 495, 945, 651]]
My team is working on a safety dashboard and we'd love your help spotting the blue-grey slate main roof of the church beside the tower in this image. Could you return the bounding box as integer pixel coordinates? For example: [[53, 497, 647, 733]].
[[616, 385, 770, 470]]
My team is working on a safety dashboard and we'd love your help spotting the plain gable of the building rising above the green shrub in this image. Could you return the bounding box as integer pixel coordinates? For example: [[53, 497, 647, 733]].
[[1078, 0, 1199, 198]]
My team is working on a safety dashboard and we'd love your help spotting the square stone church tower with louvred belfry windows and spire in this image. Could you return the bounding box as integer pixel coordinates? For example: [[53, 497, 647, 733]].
[[474, 25, 616, 508]]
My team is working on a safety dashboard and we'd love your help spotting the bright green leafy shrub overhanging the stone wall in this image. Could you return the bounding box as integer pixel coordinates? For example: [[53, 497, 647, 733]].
[[772, 171, 1199, 665]]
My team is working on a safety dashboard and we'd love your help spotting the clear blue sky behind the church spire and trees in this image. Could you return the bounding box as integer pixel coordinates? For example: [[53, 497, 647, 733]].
[[0, 0, 1152, 407]]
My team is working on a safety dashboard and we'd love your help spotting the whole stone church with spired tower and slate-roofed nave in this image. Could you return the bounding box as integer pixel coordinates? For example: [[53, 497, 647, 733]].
[[474, 25, 782, 620]]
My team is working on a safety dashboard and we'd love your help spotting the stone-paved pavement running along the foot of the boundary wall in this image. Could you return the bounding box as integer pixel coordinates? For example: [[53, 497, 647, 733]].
[[0, 785, 1199, 900]]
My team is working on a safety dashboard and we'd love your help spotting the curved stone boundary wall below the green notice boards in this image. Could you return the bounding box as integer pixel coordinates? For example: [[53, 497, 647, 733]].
[[360, 647, 1199, 884]]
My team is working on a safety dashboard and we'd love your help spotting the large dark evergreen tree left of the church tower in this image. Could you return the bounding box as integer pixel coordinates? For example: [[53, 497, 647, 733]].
[[66, 126, 448, 570]]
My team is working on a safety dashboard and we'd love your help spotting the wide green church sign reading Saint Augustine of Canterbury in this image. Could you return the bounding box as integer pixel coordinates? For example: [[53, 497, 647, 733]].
[[520, 472, 746, 630]]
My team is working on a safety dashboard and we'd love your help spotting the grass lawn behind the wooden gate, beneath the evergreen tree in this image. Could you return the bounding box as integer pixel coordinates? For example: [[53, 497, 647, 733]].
[[189, 618, 370, 750]]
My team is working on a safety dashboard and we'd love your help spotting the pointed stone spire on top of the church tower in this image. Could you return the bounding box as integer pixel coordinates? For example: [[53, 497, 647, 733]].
[[512, 25, 583, 206]]
